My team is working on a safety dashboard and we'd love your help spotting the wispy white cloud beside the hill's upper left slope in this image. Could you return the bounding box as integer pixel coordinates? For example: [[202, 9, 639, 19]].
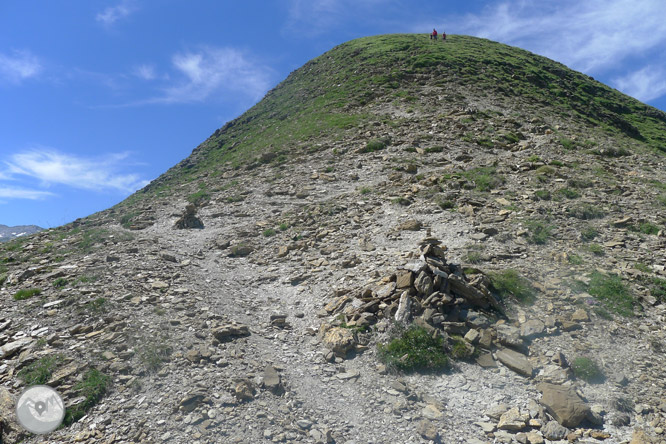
[[148, 47, 270, 103]]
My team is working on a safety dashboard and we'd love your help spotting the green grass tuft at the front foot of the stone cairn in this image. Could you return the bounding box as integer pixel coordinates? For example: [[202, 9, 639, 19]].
[[377, 326, 449, 372]]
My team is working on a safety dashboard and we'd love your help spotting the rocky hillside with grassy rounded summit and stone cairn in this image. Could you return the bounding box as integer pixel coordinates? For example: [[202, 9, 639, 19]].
[[0, 36, 666, 444]]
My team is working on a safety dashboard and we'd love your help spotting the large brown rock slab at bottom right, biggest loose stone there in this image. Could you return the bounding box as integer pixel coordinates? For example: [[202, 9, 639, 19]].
[[537, 383, 590, 428]]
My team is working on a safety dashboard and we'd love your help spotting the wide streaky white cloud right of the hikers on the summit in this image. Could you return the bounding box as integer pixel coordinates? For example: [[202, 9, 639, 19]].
[[456, 0, 666, 73]]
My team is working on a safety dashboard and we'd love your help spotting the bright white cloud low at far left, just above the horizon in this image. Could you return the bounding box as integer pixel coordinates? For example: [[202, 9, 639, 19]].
[[6, 148, 148, 192]]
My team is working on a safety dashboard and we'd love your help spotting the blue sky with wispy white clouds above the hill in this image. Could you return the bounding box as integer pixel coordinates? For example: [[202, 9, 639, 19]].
[[0, 0, 666, 227]]
